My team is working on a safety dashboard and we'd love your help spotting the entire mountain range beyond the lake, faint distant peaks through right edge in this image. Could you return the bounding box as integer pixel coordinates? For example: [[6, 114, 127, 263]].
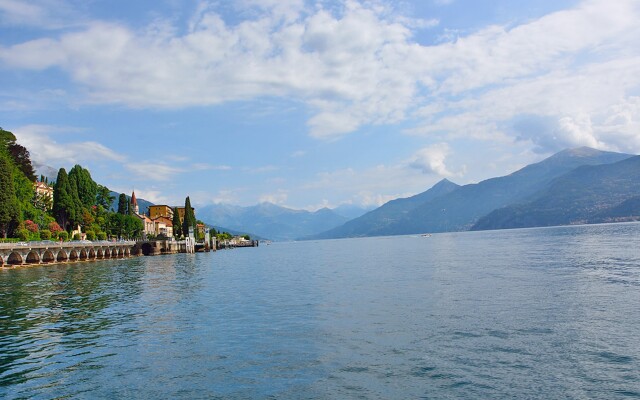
[[39, 147, 640, 240]]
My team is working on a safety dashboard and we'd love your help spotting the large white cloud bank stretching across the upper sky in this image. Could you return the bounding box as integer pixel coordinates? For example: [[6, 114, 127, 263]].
[[0, 0, 640, 151]]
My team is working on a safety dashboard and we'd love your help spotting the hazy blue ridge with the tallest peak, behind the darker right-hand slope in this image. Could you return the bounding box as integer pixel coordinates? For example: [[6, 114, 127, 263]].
[[313, 147, 633, 238]]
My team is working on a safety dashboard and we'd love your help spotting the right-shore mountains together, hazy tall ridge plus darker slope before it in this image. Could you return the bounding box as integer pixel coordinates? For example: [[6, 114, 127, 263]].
[[307, 147, 640, 239]]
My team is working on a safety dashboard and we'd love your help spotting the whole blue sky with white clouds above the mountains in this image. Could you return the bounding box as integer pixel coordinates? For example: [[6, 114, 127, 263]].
[[0, 0, 640, 210]]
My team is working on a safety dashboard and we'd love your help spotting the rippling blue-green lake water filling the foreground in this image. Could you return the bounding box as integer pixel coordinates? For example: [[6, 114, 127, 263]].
[[0, 223, 640, 399]]
